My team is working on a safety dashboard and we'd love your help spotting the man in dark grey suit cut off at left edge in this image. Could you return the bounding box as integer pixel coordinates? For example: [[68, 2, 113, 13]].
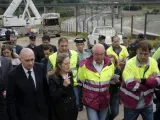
[[0, 56, 12, 120]]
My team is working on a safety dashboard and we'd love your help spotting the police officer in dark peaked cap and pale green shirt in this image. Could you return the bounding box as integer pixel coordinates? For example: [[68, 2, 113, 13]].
[[74, 38, 91, 111]]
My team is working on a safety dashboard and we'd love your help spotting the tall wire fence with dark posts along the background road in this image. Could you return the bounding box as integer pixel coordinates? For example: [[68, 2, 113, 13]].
[[46, 5, 160, 36]]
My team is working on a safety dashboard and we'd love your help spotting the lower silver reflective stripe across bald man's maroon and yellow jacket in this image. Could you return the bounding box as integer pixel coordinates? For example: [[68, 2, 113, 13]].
[[83, 84, 109, 92]]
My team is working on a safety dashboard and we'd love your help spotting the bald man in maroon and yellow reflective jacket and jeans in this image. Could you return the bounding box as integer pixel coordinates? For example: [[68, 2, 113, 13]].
[[78, 44, 114, 120]]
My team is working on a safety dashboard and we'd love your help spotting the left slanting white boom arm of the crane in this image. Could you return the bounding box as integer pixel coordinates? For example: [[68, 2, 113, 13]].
[[3, 0, 22, 17]]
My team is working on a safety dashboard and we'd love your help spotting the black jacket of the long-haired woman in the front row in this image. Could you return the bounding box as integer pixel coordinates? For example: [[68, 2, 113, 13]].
[[49, 73, 78, 120]]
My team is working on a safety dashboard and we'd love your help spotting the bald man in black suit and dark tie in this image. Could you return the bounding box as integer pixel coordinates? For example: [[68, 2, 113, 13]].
[[6, 48, 49, 120]]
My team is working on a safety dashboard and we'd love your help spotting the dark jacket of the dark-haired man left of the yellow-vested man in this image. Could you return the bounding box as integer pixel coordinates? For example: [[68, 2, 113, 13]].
[[35, 44, 57, 62]]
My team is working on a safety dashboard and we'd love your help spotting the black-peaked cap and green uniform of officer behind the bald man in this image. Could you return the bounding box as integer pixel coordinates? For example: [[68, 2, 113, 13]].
[[74, 38, 91, 111]]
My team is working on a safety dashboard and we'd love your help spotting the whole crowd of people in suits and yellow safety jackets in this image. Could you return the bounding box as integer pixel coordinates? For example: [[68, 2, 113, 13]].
[[0, 33, 160, 120]]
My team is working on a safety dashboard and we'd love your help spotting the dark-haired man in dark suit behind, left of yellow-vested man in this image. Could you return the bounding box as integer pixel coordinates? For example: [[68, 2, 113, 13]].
[[36, 35, 57, 62]]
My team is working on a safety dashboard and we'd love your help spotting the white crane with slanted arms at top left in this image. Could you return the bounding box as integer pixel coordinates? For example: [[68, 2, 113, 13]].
[[0, 0, 41, 27]]
